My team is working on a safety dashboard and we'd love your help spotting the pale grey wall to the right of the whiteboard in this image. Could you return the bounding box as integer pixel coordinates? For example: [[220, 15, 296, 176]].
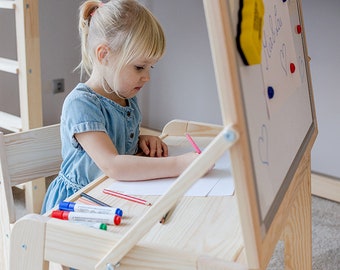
[[302, 0, 340, 177]]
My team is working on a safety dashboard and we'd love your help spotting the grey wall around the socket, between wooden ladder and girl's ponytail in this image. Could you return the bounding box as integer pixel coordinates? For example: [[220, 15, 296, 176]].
[[39, 0, 83, 125]]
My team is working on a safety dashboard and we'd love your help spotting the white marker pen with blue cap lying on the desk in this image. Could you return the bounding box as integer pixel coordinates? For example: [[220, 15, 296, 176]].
[[59, 202, 123, 217]]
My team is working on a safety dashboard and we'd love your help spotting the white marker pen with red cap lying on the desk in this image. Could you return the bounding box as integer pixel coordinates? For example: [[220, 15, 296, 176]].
[[52, 210, 121, 225]]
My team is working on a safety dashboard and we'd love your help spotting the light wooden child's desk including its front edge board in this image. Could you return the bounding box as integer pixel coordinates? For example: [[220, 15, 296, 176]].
[[12, 123, 250, 269]]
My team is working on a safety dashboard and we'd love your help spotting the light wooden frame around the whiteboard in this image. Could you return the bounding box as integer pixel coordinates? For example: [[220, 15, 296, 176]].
[[203, 0, 317, 268]]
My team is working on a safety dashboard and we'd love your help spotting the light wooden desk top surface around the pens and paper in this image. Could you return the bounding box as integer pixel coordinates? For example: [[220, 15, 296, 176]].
[[67, 136, 243, 261]]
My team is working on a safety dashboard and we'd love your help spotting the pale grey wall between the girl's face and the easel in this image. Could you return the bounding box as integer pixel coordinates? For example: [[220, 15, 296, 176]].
[[140, 0, 222, 129]]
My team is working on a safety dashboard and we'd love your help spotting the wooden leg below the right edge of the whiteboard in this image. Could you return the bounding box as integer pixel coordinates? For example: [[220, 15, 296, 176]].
[[282, 172, 312, 270]]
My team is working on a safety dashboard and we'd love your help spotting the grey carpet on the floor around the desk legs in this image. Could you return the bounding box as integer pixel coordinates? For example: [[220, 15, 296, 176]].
[[15, 190, 340, 270]]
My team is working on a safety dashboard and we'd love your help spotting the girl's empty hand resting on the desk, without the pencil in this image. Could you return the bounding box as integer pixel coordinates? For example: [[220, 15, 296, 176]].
[[139, 135, 168, 157]]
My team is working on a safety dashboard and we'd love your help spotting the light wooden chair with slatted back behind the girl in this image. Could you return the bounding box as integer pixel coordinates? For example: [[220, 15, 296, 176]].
[[0, 124, 61, 269]]
